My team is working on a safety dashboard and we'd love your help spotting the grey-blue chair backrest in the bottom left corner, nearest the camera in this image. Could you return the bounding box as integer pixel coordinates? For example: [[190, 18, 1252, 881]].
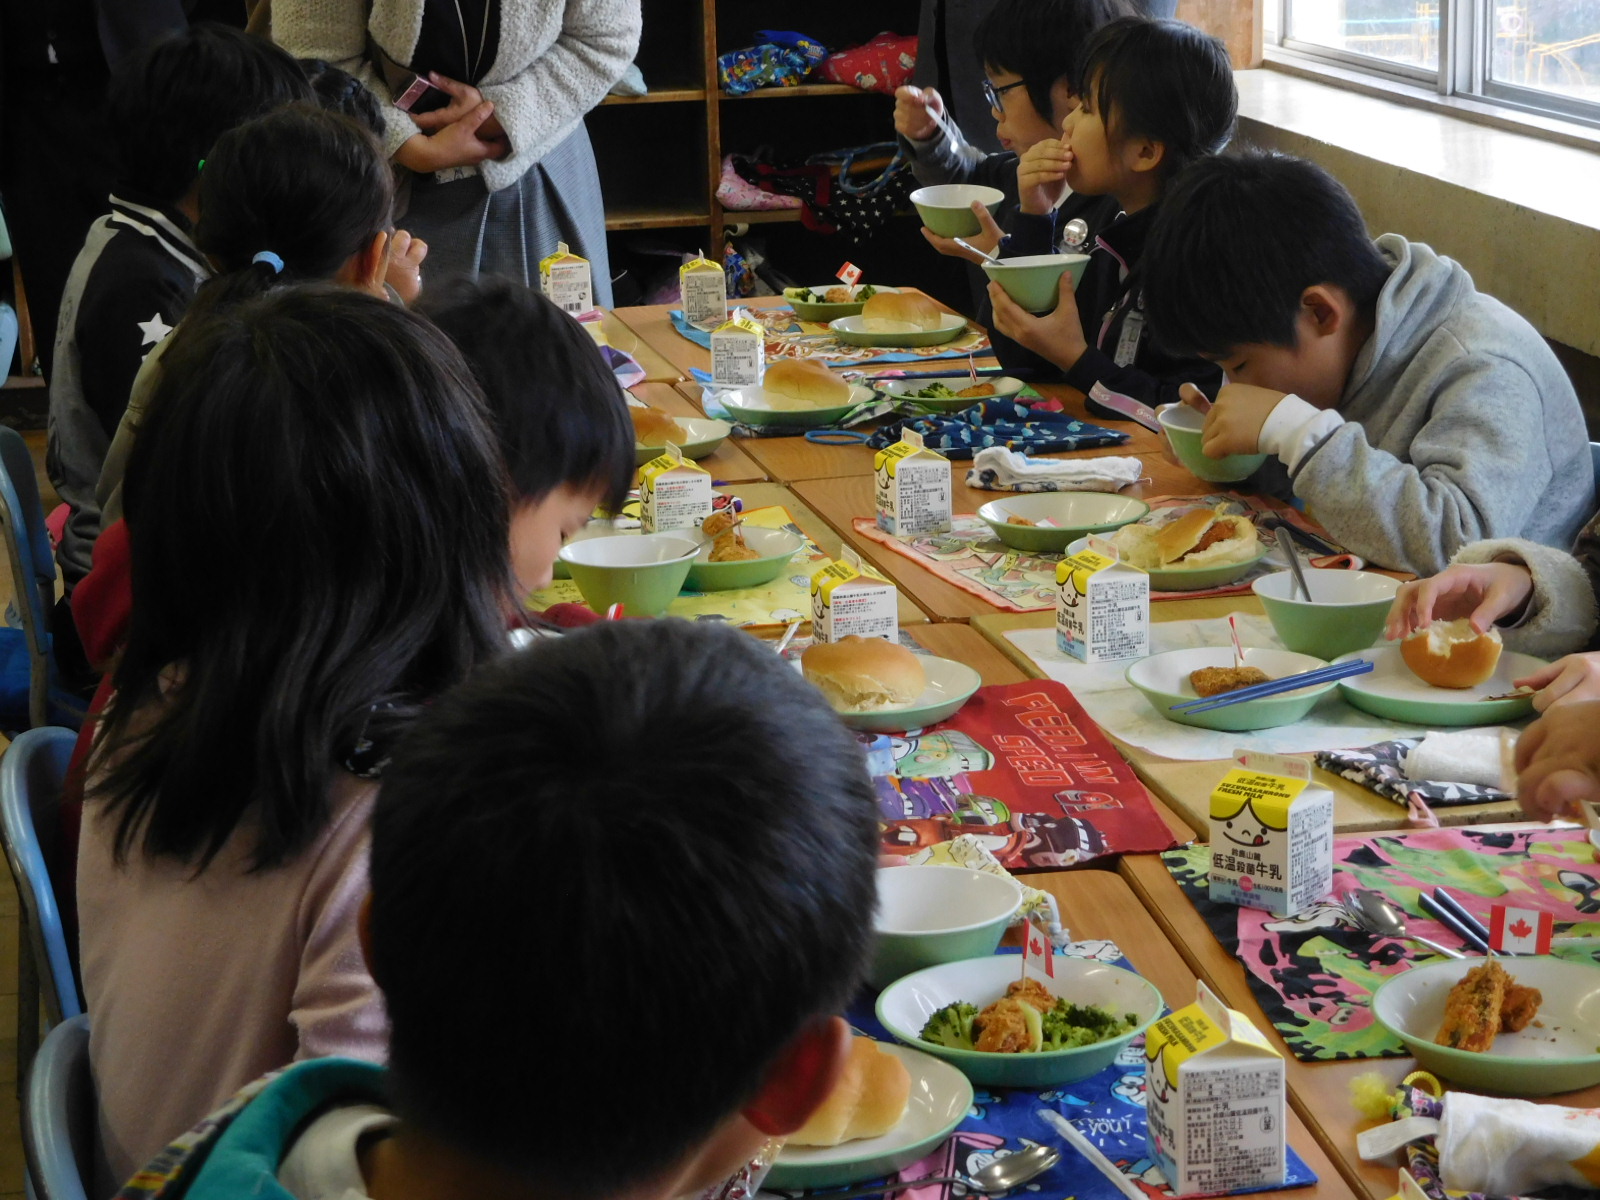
[[22, 1016, 99, 1200]]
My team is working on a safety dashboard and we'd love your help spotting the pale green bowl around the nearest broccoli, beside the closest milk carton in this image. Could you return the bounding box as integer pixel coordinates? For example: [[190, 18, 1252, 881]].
[[877, 954, 1162, 1088]]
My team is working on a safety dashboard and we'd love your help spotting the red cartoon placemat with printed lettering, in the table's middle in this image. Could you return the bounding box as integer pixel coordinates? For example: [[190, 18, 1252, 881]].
[[861, 680, 1173, 870]]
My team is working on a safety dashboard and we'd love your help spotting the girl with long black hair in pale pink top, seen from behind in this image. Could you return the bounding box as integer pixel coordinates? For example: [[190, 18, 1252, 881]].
[[77, 288, 509, 1195]]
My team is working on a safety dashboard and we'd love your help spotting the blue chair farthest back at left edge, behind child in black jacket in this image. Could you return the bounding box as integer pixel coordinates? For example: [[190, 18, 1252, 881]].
[[0, 426, 88, 730]]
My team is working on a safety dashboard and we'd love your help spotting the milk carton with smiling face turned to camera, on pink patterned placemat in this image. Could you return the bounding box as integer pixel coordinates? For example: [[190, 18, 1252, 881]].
[[1211, 754, 1333, 917]]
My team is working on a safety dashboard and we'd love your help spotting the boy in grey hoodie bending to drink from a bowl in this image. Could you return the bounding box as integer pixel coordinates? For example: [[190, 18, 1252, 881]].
[[1146, 152, 1595, 574]]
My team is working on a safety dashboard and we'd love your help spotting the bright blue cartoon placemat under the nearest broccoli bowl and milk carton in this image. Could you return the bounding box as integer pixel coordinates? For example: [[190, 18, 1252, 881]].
[[771, 942, 1317, 1200]]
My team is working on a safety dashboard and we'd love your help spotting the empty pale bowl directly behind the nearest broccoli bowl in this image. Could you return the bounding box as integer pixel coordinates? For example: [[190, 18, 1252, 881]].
[[870, 866, 1022, 987]]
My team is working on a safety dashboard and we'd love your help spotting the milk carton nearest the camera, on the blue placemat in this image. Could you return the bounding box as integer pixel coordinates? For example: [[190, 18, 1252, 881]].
[[1144, 984, 1288, 1195]]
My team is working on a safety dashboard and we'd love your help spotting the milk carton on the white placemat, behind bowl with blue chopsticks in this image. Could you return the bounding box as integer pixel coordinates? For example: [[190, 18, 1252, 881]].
[[1056, 538, 1150, 662]]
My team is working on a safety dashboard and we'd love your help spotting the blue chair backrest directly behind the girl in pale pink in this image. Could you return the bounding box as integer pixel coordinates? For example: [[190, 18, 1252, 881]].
[[0, 725, 83, 1026]]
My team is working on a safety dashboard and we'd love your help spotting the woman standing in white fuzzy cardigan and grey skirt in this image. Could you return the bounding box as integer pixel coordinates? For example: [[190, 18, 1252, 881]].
[[272, 0, 642, 306]]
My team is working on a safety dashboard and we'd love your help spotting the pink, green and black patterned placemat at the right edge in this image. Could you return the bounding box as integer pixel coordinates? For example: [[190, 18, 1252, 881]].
[[1162, 829, 1600, 1062]]
